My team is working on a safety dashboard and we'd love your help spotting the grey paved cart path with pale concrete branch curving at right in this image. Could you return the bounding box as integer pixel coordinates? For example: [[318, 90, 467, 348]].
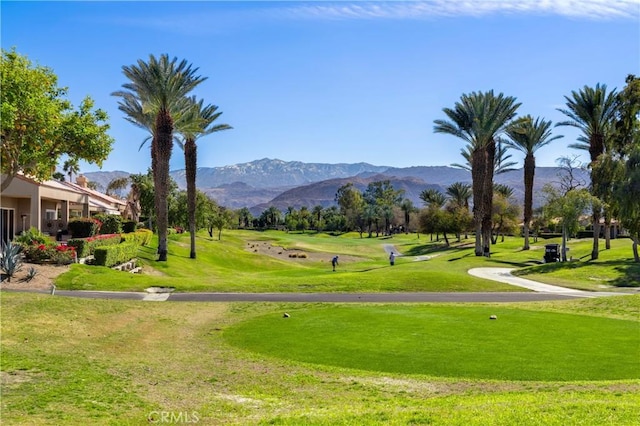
[[3, 268, 624, 303]]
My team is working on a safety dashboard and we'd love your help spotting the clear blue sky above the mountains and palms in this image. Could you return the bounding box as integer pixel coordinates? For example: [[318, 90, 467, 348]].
[[0, 0, 640, 173]]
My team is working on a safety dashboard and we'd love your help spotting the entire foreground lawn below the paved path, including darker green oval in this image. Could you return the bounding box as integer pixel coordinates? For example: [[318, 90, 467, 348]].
[[0, 292, 640, 425]]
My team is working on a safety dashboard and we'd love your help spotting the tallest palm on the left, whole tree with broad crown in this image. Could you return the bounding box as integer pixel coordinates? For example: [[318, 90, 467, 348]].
[[113, 54, 206, 261]]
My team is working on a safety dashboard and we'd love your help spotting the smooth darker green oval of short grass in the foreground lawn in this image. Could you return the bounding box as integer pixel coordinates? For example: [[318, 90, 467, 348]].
[[225, 302, 640, 380]]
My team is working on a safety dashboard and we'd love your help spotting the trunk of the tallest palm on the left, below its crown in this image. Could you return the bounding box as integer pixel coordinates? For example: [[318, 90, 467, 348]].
[[153, 111, 173, 262]]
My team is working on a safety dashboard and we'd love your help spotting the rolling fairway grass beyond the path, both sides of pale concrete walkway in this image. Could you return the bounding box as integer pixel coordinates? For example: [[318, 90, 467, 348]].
[[56, 231, 640, 292]]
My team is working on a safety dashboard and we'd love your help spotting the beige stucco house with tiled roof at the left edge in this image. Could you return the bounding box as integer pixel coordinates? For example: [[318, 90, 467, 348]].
[[0, 175, 126, 241]]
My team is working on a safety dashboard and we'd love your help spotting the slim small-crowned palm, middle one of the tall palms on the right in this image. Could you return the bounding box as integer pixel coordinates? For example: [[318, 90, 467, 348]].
[[506, 115, 563, 250]]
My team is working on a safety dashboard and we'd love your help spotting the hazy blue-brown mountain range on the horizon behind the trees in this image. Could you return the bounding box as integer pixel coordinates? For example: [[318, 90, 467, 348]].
[[85, 158, 589, 215]]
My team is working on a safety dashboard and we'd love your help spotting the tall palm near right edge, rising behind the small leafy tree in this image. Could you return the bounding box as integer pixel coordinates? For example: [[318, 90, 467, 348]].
[[556, 83, 617, 260]]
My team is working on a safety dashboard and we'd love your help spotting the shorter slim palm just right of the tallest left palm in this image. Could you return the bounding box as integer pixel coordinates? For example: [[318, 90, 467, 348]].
[[176, 97, 232, 259]]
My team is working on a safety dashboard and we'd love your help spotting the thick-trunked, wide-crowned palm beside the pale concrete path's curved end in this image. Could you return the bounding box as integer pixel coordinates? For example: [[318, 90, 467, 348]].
[[434, 90, 520, 256]]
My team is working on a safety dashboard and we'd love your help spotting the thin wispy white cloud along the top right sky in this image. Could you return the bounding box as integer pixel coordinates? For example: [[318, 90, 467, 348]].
[[286, 0, 640, 20]]
